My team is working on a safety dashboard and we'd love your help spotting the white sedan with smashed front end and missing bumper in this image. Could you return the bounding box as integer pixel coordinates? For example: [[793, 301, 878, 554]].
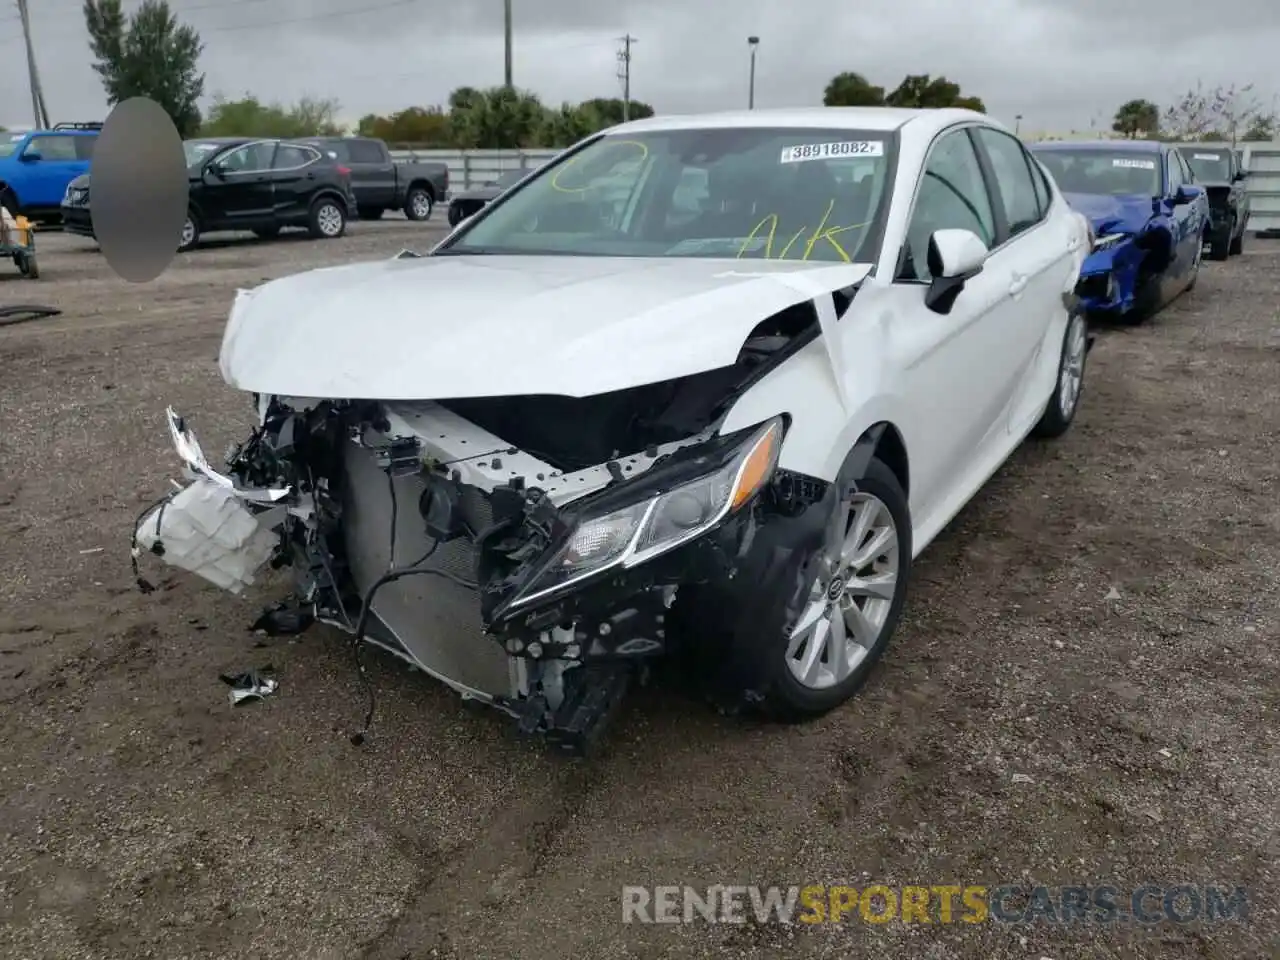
[[134, 108, 1092, 749]]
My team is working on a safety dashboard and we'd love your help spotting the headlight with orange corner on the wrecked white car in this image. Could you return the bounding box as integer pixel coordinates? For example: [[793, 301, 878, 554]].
[[515, 417, 783, 605]]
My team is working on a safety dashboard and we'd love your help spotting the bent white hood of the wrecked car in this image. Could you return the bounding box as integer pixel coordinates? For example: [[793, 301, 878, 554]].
[[220, 255, 870, 399]]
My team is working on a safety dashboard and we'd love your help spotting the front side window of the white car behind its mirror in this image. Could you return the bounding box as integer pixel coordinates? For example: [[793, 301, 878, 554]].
[[900, 129, 996, 283]]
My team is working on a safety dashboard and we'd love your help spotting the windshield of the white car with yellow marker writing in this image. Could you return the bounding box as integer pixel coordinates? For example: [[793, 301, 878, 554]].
[[439, 128, 896, 262]]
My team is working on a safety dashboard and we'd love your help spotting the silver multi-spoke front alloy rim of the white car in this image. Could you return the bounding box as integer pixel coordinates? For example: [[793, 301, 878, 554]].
[[787, 493, 901, 690]]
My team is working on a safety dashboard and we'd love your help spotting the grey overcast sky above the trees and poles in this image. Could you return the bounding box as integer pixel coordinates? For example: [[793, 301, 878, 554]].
[[0, 0, 1280, 132]]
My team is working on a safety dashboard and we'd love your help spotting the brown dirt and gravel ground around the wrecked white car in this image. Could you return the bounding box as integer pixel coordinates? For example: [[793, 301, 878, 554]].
[[0, 223, 1280, 960]]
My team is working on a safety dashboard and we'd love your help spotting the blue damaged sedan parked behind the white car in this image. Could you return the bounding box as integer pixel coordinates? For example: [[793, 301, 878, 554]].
[[1030, 140, 1210, 324]]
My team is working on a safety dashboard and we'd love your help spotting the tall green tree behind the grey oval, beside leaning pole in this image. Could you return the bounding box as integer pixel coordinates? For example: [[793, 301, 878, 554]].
[[83, 0, 205, 137]]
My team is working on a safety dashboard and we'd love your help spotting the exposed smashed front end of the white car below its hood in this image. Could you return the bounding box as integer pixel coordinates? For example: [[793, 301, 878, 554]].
[[133, 304, 834, 751]]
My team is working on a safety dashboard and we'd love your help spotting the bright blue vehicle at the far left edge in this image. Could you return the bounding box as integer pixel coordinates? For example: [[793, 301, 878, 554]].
[[0, 123, 102, 223]]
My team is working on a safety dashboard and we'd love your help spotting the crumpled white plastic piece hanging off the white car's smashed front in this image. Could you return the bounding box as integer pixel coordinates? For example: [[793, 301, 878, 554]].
[[137, 477, 288, 594]]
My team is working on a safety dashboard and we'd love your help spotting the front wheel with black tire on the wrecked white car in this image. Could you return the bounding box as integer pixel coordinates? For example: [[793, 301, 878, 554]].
[[756, 458, 911, 722]]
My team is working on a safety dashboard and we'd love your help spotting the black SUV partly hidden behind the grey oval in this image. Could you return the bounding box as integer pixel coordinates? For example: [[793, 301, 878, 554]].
[[63, 137, 356, 251]]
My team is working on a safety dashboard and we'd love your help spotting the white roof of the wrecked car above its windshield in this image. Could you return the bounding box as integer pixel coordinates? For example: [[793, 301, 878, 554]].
[[608, 106, 991, 136]]
